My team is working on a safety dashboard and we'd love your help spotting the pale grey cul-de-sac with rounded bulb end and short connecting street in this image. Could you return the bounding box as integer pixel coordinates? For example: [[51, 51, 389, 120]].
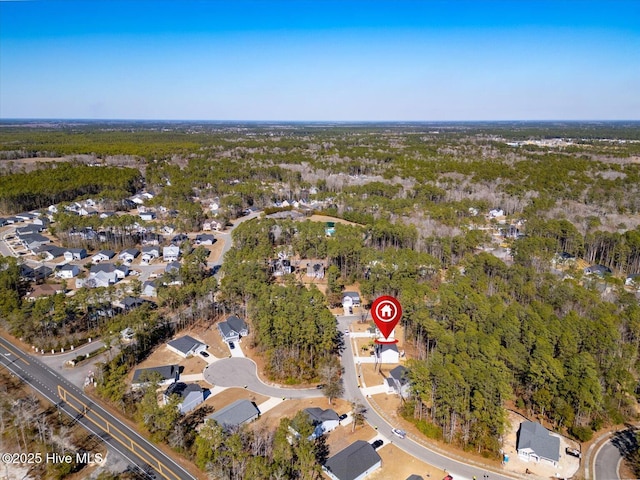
[[204, 358, 323, 398]]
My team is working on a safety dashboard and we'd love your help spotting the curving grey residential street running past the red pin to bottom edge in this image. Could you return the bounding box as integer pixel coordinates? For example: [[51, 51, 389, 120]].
[[337, 315, 515, 480]]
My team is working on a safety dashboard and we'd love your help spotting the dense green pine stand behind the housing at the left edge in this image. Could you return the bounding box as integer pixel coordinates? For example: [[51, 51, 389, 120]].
[[0, 163, 142, 213]]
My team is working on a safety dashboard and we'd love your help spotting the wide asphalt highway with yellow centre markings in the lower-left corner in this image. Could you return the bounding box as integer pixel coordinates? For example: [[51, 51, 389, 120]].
[[0, 337, 194, 480]]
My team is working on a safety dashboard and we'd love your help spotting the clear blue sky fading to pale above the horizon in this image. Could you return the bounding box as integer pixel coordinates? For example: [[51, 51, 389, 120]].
[[0, 0, 640, 121]]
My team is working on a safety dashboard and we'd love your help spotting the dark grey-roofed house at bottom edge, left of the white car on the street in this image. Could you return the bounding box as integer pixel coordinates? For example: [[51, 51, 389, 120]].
[[322, 440, 382, 480]]
